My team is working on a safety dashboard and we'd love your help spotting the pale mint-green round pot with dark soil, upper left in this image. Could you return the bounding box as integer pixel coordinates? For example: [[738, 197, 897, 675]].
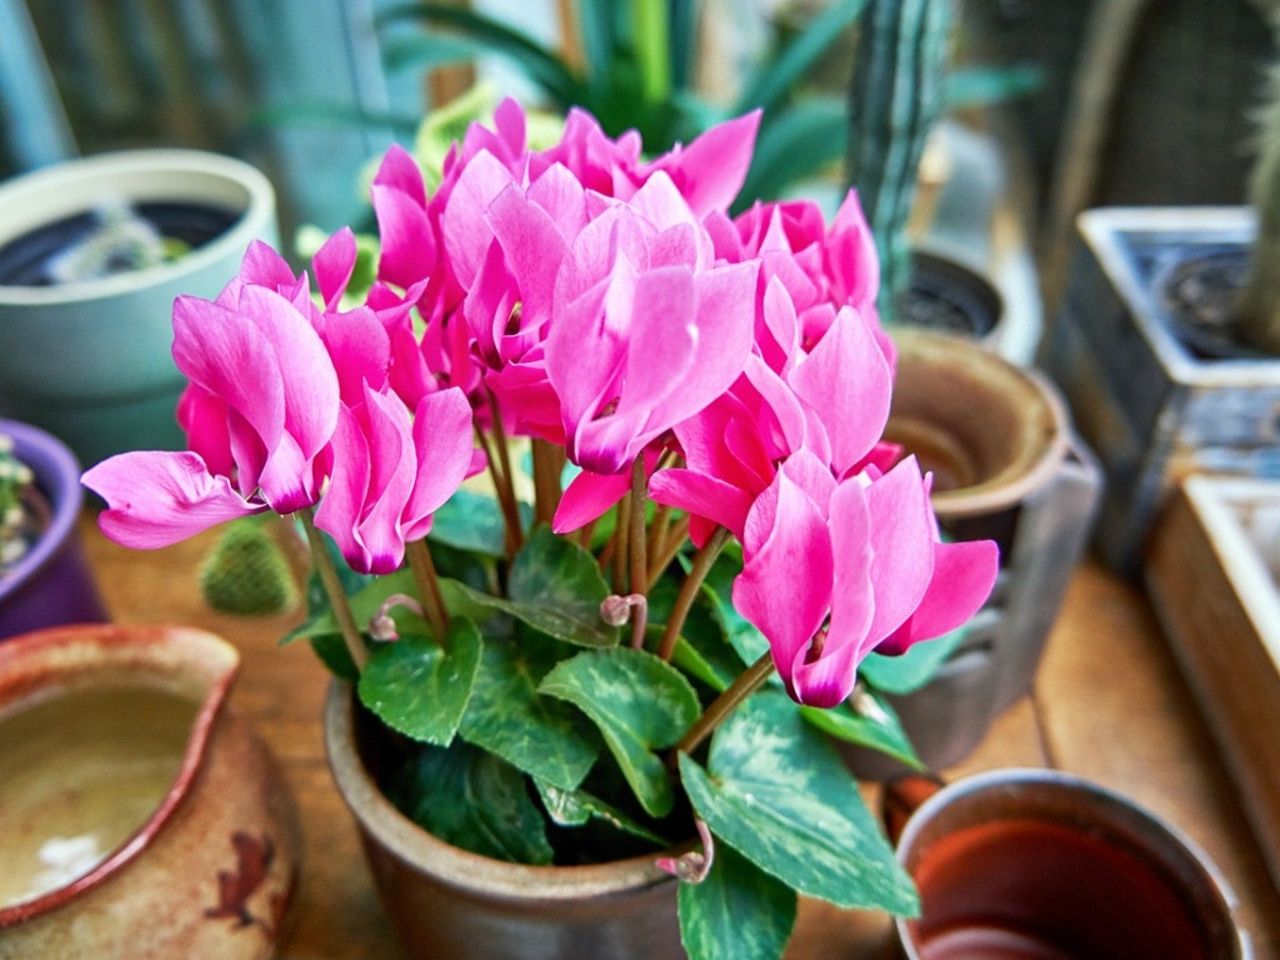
[[0, 150, 276, 466]]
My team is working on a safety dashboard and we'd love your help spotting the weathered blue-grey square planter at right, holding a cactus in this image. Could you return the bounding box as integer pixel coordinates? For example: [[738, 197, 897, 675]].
[[1043, 207, 1280, 573]]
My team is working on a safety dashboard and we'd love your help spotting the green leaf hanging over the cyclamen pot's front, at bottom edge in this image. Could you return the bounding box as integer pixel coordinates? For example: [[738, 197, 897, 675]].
[[678, 844, 796, 960]]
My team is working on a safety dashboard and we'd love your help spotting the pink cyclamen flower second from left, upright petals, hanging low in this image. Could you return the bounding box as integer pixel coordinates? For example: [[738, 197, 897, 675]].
[[316, 387, 474, 573]]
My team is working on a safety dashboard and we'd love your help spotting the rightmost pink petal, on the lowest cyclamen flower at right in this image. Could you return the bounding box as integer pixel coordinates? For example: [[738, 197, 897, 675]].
[[876, 540, 1000, 654]]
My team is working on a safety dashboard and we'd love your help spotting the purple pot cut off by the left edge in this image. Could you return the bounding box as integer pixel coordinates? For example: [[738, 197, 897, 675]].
[[0, 420, 108, 640]]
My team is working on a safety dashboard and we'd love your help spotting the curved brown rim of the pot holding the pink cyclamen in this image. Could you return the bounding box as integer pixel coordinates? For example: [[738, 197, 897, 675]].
[[324, 680, 682, 902]]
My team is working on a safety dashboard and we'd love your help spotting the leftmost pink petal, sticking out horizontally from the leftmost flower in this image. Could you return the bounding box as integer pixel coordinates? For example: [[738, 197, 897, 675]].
[[81, 451, 264, 550]]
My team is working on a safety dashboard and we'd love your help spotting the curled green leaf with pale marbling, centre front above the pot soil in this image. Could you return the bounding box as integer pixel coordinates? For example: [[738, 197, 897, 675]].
[[539, 648, 699, 818]]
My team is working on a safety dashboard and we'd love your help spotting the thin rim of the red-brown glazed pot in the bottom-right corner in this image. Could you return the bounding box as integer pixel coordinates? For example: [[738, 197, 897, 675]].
[[893, 767, 1253, 960]]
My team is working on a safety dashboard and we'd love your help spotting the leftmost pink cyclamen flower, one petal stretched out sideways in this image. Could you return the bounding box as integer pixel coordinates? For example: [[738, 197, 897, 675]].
[[83, 256, 339, 549]]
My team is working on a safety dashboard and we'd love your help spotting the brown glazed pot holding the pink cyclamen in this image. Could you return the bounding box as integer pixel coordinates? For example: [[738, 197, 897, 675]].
[[325, 681, 681, 960]]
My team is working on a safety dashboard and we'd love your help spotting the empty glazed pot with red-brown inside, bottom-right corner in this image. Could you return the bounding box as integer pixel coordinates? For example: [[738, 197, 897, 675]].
[[886, 769, 1252, 960]]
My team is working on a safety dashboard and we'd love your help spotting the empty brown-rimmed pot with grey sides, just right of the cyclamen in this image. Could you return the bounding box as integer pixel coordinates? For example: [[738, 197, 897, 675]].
[[851, 329, 1101, 778]]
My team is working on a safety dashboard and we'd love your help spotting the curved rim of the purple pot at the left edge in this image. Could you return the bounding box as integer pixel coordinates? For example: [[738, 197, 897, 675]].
[[0, 420, 84, 603]]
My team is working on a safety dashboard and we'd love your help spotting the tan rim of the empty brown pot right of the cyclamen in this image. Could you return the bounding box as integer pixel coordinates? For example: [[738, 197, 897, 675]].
[[891, 328, 1071, 520]]
